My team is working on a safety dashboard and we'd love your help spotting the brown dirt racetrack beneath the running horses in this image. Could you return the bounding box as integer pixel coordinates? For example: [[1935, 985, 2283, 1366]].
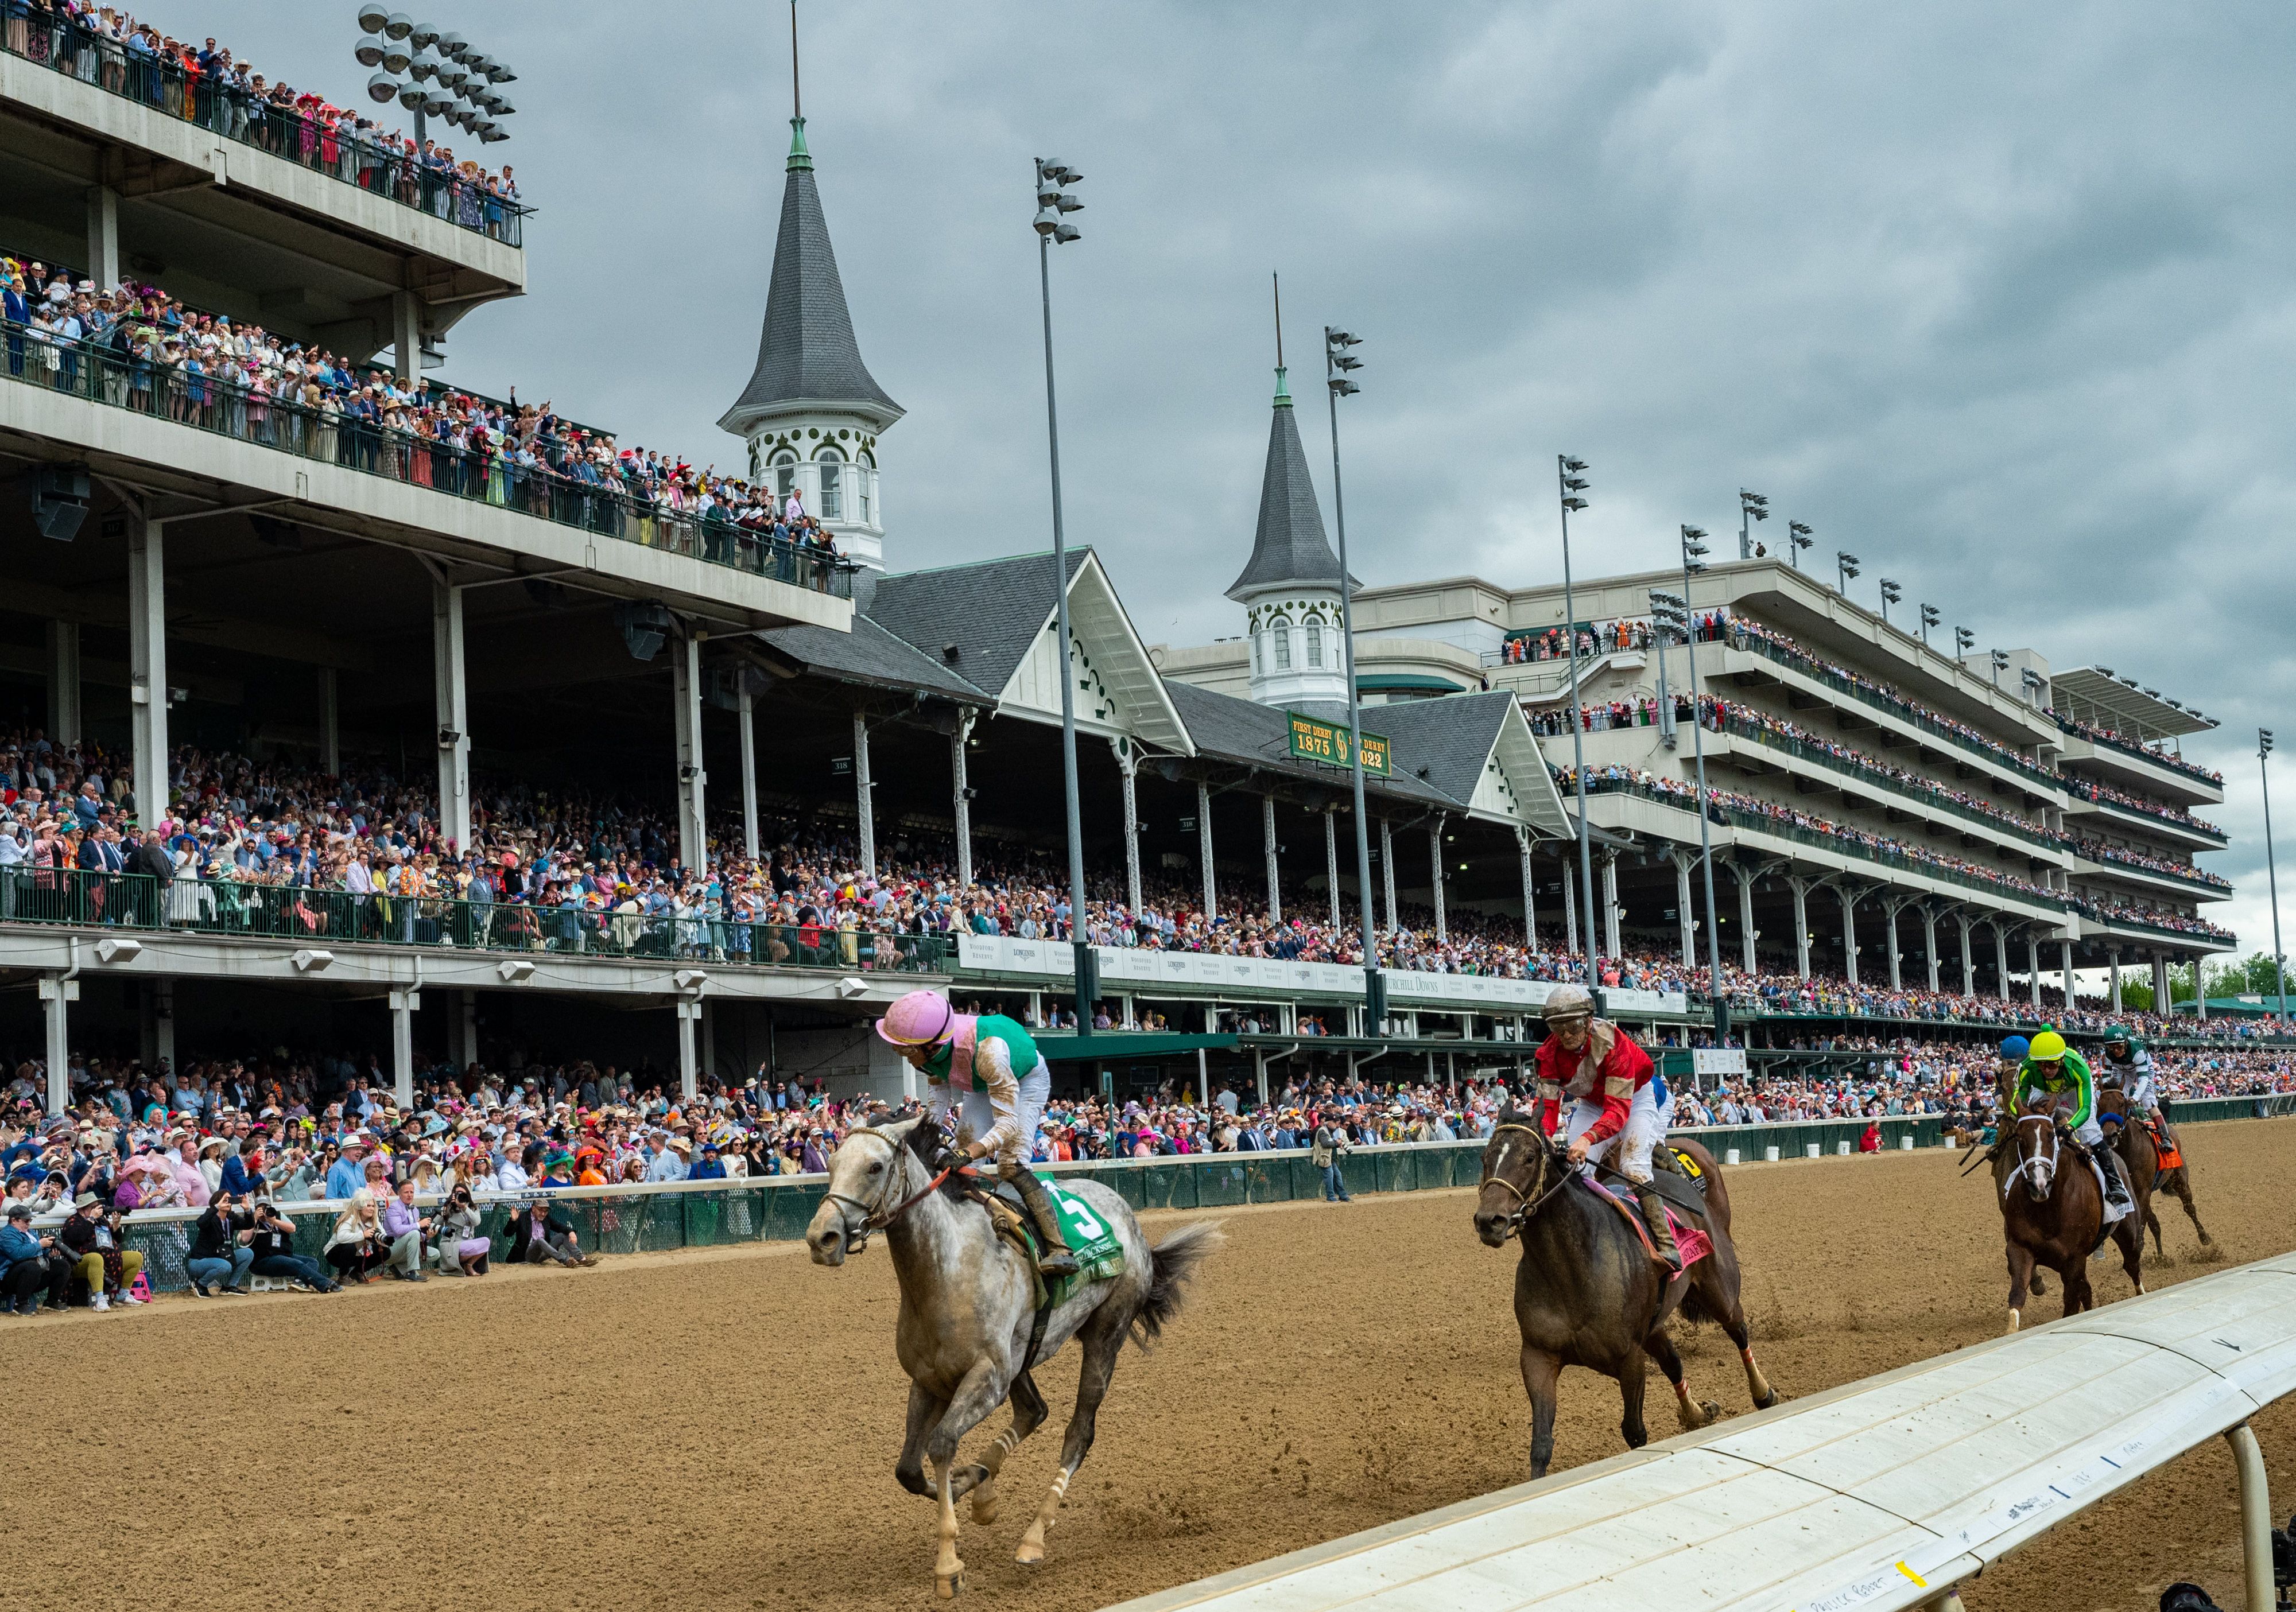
[[18, 1121, 2296, 1612]]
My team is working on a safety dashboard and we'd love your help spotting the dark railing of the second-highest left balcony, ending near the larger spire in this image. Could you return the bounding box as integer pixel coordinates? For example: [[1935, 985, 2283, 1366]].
[[0, 324, 859, 599]]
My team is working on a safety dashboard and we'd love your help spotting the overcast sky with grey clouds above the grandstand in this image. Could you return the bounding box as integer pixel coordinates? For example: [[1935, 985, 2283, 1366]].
[[179, 0, 2296, 973]]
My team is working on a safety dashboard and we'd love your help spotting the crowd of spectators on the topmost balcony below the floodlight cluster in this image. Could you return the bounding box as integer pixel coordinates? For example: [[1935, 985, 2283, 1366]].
[[0, 0, 523, 243]]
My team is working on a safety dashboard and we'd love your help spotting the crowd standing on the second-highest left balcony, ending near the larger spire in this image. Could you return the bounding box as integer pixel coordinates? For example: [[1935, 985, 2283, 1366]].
[[0, 257, 843, 588]]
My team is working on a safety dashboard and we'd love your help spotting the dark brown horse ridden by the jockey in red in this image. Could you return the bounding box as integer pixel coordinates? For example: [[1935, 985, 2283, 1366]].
[[1474, 1109, 1777, 1479]]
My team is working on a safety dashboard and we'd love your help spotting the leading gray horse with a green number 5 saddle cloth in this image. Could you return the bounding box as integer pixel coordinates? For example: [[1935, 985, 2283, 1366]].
[[806, 1118, 1224, 1601]]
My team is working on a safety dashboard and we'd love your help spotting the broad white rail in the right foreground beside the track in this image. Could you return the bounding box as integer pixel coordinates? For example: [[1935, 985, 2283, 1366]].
[[1102, 1254, 2296, 1612]]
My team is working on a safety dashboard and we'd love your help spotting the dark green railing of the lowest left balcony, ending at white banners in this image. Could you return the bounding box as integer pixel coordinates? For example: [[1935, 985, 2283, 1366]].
[[0, 866, 957, 974]]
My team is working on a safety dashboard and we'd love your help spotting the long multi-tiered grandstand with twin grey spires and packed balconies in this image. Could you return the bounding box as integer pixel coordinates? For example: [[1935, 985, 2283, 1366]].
[[0, 28, 2275, 1125]]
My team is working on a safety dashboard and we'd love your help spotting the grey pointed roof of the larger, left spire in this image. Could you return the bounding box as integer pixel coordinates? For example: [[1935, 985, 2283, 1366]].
[[719, 129, 902, 434]]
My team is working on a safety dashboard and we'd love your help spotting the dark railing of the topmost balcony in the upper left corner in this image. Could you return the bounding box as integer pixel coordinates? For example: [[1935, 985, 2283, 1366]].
[[0, 0, 533, 246]]
